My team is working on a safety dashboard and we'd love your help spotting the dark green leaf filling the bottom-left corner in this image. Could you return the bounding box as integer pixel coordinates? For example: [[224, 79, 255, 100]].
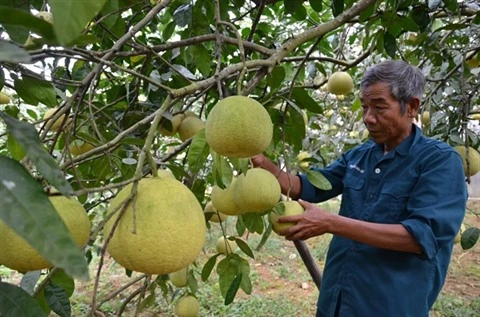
[[0, 282, 47, 317]]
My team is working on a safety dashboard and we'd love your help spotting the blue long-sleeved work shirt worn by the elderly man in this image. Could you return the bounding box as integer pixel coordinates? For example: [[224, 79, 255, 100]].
[[300, 126, 467, 317]]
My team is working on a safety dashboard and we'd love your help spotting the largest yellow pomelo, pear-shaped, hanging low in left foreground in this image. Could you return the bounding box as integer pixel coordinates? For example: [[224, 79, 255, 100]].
[[104, 177, 206, 274]]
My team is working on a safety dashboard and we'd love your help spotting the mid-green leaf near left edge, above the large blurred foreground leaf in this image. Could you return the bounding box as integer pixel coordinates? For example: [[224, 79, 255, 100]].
[[14, 76, 57, 108]]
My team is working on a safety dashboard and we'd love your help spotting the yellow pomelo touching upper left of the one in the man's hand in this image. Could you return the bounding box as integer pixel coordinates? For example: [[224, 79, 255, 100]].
[[233, 168, 281, 212]]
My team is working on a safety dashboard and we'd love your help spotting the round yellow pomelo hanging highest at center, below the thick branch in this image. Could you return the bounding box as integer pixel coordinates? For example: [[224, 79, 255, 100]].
[[205, 96, 273, 157]]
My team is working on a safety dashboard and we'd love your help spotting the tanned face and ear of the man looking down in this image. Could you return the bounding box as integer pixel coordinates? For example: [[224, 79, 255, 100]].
[[360, 83, 419, 151]]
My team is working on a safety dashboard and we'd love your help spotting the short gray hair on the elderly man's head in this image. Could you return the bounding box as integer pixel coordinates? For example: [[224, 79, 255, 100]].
[[360, 60, 425, 113]]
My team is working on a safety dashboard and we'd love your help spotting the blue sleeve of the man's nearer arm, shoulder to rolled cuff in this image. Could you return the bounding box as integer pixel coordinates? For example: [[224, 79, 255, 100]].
[[402, 148, 468, 260]]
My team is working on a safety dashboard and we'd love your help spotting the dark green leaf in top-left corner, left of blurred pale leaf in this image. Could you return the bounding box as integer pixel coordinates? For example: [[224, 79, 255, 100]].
[[0, 6, 55, 41]]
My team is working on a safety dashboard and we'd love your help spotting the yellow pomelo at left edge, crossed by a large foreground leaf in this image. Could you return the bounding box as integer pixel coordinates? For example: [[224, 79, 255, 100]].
[[0, 196, 90, 272]]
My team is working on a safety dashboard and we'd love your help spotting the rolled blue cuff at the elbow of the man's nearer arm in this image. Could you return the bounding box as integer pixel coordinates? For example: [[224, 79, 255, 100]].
[[401, 219, 438, 260]]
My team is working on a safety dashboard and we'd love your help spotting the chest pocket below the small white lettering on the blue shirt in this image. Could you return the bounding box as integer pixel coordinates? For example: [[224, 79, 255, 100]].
[[340, 173, 365, 219]]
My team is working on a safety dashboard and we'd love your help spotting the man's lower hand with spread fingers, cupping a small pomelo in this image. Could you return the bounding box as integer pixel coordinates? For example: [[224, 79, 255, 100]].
[[277, 199, 335, 240]]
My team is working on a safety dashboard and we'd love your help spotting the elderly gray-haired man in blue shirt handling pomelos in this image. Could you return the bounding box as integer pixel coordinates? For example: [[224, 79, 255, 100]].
[[252, 61, 467, 317]]
